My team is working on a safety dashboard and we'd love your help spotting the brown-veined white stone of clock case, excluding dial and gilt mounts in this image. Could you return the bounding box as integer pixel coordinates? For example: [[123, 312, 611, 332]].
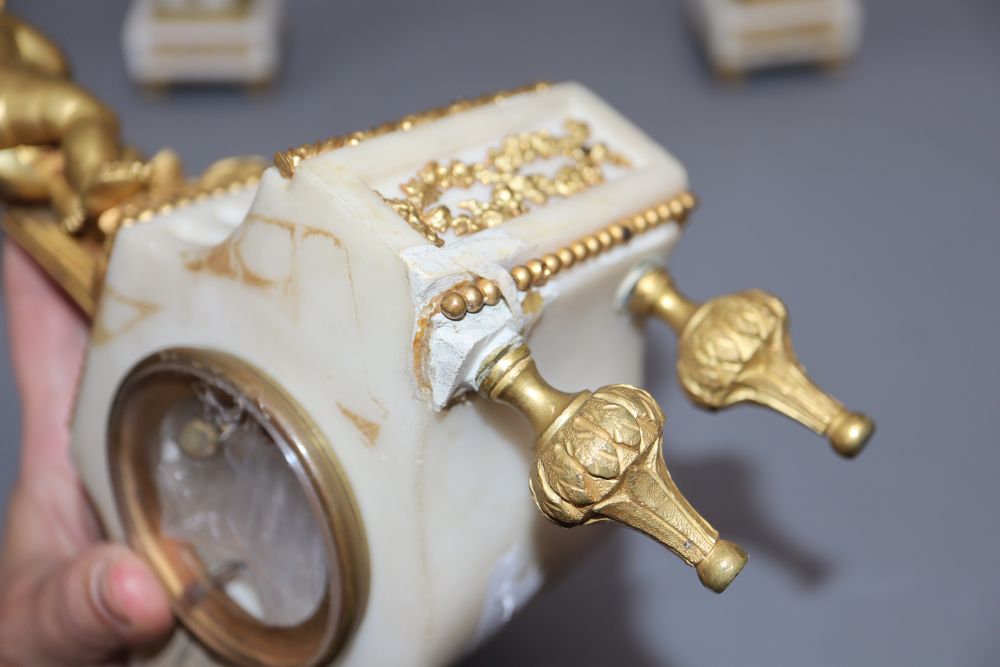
[[73, 84, 687, 667]]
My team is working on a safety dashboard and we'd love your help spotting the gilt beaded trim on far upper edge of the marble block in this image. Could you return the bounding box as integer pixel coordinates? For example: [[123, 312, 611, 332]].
[[274, 81, 550, 178]]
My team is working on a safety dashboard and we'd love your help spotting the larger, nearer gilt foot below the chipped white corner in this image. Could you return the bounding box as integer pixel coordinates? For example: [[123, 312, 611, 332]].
[[479, 346, 747, 593]]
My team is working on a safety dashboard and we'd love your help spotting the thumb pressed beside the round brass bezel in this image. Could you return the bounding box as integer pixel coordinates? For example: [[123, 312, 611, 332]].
[[0, 543, 172, 665]]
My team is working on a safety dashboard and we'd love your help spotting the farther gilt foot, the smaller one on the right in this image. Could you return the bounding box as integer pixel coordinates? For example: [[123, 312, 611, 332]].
[[629, 267, 875, 458]]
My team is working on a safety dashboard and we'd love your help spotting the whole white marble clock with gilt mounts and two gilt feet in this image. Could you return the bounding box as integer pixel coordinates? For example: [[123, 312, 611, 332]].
[[0, 66, 873, 667]]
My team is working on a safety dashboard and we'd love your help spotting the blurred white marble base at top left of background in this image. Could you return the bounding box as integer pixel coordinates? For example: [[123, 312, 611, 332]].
[[122, 0, 284, 85]]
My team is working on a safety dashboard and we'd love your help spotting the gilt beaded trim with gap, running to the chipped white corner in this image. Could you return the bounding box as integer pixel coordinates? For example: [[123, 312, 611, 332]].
[[439, 192, 698, 320]]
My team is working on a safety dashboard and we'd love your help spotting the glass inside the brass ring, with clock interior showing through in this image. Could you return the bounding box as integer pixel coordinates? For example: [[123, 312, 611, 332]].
[[154, 388, 328, 627]]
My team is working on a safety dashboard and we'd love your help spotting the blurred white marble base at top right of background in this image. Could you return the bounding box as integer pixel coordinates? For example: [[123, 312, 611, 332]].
[[691, 0, 862, 76]]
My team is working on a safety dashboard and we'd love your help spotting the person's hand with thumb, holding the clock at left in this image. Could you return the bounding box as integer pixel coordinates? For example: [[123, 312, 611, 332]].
[[0, 241, 173, 667]]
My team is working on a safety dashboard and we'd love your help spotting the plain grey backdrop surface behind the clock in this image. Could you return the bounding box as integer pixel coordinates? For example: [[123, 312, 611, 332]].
[[0, 0, 1000, 667]]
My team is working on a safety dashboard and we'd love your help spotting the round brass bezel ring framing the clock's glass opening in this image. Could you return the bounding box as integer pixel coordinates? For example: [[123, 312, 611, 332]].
[[108, 348, 369, 667]]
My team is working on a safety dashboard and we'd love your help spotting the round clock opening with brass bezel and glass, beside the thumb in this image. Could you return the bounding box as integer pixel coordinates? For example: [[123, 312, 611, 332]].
[[108, 349, 367, 667]]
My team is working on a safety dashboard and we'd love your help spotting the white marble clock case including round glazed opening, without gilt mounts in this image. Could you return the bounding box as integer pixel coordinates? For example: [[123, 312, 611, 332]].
[[73, 84, 704, 665]]
